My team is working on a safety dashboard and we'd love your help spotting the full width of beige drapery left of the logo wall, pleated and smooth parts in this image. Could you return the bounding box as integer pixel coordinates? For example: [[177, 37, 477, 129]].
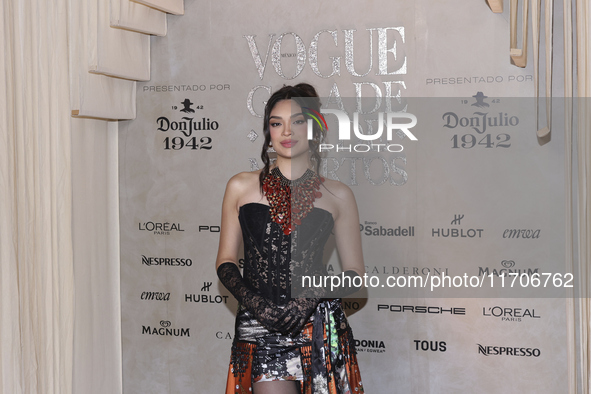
[[0, 0, 123, 394]]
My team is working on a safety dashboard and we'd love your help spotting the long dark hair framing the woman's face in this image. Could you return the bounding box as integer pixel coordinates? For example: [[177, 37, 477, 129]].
[[259, 83, 324, 189]]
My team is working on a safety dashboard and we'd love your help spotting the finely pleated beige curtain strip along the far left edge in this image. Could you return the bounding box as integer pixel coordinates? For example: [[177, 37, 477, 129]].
[[0, 0, 74, 393]]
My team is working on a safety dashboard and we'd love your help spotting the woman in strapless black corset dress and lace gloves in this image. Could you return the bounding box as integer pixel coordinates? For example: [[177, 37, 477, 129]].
[[216, 84, 364, 394]]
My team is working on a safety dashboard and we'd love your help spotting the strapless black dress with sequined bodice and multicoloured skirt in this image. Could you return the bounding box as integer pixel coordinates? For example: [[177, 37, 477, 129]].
[[226, 203, 363, 394]]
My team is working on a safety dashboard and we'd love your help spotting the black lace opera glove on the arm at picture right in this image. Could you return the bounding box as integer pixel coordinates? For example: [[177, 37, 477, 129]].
[[278, 270, 362, 336]]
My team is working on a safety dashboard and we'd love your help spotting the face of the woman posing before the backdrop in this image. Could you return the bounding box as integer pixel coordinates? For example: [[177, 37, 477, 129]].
[[269, 100, 309, 159]]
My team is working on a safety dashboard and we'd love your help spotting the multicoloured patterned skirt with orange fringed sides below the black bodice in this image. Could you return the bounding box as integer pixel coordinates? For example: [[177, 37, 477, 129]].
[[226, 299, 363, 394]]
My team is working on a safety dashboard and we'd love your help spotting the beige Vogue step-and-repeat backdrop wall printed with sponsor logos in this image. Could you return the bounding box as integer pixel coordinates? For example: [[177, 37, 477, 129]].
[[119, 0, 574, 393]]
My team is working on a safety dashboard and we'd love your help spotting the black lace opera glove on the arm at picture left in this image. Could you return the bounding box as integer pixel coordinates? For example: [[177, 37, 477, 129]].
[[217, 262, 286, 332]]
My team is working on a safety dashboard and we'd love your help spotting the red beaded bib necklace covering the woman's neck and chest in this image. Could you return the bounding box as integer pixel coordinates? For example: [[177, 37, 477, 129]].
[[263, 167, 324, 235]]
